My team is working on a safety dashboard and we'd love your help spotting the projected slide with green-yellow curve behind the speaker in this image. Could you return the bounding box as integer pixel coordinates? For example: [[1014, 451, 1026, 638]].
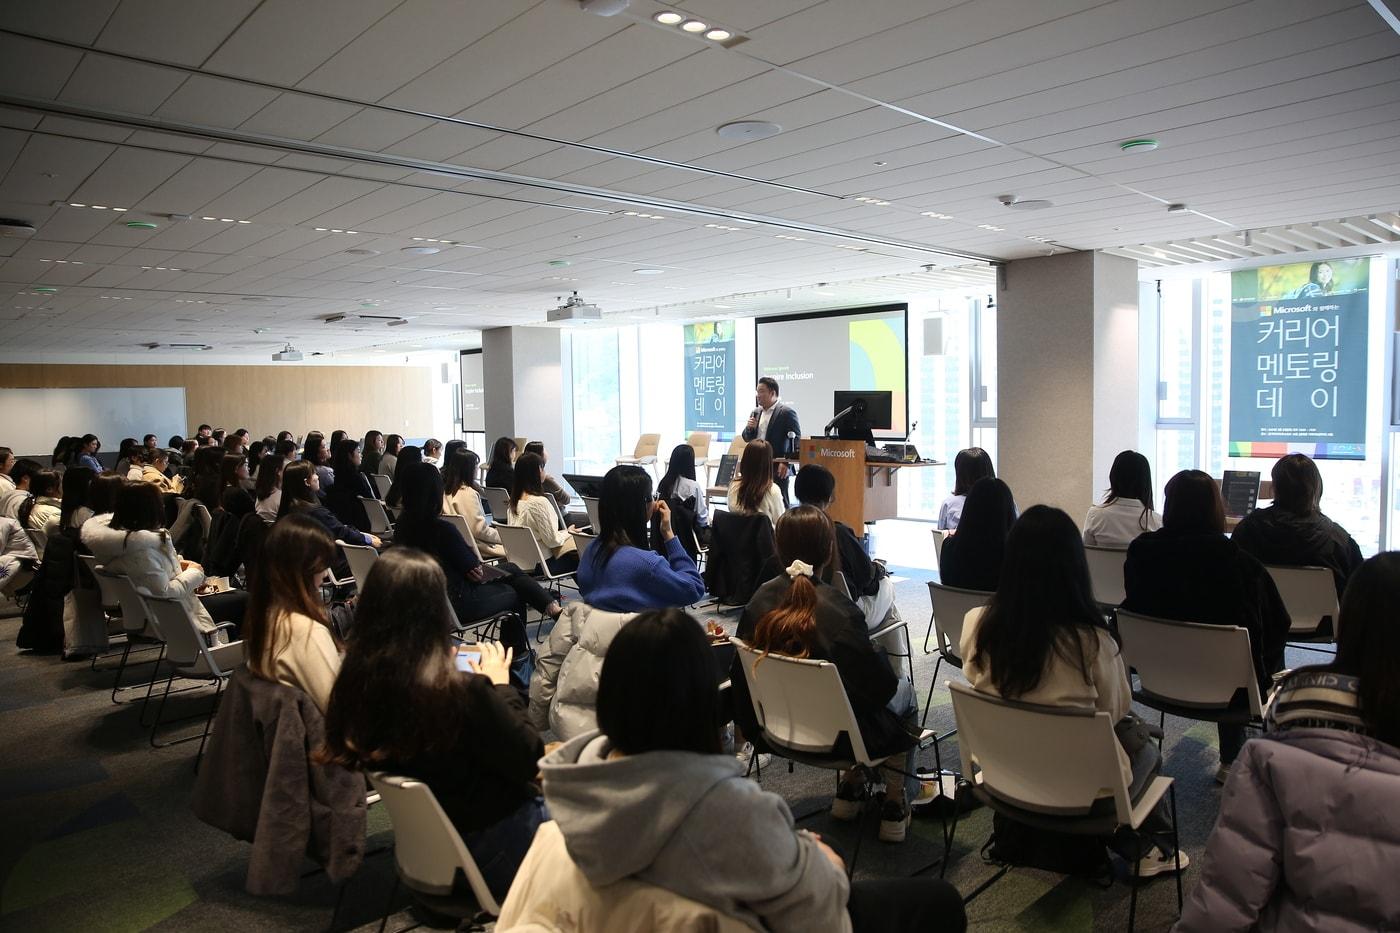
[[756, 304, 909, 440]]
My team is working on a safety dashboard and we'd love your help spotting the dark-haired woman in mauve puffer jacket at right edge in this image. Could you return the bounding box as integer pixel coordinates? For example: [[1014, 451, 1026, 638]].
[[1175, 552, 1400, 933]]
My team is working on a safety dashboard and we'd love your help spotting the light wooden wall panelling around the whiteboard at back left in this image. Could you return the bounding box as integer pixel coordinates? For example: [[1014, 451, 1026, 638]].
[[0, 363, 433, 439]]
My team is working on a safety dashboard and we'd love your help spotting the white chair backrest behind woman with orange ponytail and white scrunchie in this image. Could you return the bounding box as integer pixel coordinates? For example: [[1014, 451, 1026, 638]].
[[729, 639, 876, 765]]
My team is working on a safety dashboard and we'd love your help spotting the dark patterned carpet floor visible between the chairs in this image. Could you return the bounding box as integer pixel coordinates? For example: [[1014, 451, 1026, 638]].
[[0, 567, 1315, 933]]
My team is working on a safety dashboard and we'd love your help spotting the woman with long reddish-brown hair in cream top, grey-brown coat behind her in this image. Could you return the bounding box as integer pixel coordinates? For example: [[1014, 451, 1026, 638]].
[[244, 514, 340, 713]]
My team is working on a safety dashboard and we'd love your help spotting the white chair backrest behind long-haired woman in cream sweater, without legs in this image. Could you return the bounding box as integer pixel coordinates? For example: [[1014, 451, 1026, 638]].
[[946, 681, 1133, 824]]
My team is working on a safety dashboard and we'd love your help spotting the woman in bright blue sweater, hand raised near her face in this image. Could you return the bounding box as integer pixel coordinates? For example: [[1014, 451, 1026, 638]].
[[578, 467, 704, 612]]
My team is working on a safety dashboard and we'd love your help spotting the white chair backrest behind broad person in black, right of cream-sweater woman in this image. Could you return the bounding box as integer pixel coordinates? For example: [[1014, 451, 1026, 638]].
[[1117, 609, 1261, 717]]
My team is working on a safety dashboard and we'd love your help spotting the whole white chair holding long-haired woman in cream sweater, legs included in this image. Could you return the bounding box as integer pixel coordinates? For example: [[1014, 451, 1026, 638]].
[[944, 681, 1182, 930]]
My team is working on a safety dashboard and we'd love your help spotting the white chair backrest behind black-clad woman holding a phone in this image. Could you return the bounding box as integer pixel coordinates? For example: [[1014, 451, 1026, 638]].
[[370, 770, 501, 916]]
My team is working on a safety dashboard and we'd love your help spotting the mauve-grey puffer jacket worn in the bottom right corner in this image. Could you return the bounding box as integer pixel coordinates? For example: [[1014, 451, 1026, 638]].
[[1175, 728, 1400, 933]]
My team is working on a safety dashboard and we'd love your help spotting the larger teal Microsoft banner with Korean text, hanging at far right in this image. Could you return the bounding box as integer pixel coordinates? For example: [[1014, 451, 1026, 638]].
[[1229, 259, 1371, 459]]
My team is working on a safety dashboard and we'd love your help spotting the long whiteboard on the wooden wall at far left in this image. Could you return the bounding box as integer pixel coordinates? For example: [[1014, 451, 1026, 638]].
[[0, 387, 185, 464]]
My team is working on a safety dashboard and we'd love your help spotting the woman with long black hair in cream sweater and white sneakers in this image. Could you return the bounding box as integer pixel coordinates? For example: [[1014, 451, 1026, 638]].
[[955, 501, 1189, 877]]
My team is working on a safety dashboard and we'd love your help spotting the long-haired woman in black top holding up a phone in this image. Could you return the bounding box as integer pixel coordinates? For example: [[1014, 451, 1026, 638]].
[[319, 548, 549, 901]]
